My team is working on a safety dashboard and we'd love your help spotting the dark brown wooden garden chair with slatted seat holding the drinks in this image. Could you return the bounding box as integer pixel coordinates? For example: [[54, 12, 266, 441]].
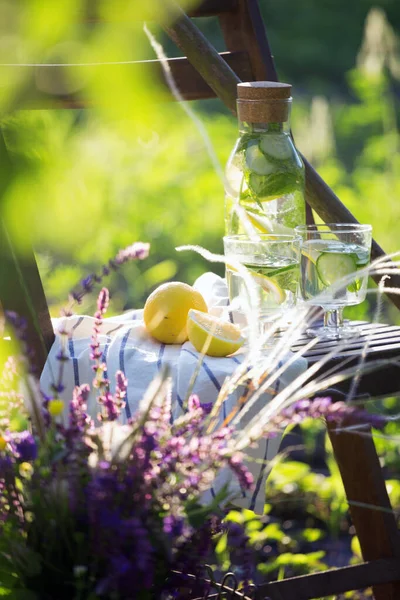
[[0, 0, 400, 600]]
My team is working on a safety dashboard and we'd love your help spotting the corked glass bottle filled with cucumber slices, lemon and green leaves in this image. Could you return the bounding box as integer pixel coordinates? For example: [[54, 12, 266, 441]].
[[225, 81, 305, 235]]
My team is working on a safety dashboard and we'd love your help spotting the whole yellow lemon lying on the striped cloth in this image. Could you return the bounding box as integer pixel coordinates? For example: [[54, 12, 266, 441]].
[[143, 281, 207, 344]]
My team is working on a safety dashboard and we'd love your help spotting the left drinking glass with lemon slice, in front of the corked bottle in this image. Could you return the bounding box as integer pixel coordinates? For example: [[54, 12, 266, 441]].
[[224, 234, 301, 333]]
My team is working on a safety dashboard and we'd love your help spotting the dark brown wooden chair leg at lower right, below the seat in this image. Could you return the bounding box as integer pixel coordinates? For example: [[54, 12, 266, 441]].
[[328, 424, 400, 600]]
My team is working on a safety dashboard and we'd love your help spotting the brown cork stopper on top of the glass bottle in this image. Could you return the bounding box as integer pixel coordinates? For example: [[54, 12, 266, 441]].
[[237, 81, 292, 123]]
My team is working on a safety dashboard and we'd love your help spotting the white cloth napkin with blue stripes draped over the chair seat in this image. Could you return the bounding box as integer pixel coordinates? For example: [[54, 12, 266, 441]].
[[41, 273, 307, 512]]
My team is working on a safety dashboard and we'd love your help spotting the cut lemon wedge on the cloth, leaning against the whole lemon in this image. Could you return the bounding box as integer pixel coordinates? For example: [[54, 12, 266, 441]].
[[187, 308, 244, 356]]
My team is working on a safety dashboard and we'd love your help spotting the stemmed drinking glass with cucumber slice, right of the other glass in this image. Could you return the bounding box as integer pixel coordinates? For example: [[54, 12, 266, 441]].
[[295, 223, 372, 339]]
